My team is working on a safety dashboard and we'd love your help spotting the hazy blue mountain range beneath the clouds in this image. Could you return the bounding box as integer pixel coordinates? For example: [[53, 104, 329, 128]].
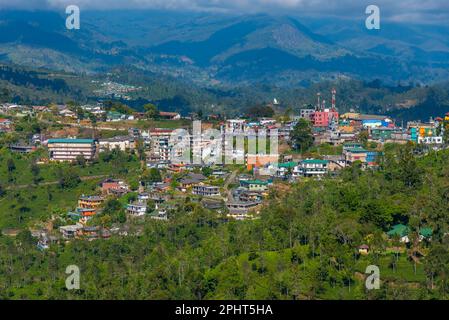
[[0, 10, 449, 87]]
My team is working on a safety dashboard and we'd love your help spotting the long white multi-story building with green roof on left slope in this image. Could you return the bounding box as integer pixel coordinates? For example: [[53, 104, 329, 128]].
[[48, 139, 97, 161]]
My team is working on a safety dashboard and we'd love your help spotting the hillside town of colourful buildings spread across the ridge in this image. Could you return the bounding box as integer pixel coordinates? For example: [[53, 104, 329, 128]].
[[0, 90, 449, 253]]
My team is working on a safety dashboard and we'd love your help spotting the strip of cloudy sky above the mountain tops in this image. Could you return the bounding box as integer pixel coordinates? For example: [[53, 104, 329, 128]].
[[0, 0, 449, 24]]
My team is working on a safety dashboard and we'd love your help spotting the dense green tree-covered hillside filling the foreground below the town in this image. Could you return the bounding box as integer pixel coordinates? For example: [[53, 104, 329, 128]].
[[0, 146, 449, 299]]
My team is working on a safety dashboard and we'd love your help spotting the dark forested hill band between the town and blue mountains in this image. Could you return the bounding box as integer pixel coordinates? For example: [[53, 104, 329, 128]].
[[0, 65, 449, 121]]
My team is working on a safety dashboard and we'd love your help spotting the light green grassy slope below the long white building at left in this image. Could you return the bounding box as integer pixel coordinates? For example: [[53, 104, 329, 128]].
[[0, 149, 140, 229]]
